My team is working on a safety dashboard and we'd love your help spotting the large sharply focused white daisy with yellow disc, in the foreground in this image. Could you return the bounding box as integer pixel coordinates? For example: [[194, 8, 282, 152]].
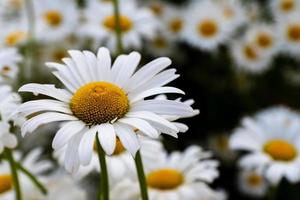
[[17, 48, 193, 172]]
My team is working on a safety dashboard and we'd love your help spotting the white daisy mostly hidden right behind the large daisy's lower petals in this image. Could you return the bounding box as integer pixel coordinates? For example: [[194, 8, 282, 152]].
[[54, 136, 163, 181]]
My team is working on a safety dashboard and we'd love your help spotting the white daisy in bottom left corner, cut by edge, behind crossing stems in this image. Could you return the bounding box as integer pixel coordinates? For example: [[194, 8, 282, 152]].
[[0, 149, 53, 200]]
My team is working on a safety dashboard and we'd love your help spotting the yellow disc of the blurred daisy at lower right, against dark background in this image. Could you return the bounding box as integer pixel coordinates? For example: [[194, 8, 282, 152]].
[[264, 139, 297, 161]]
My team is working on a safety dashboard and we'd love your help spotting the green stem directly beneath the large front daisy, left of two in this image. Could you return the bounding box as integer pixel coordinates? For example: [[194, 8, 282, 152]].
[[96, 136, 109, 200]]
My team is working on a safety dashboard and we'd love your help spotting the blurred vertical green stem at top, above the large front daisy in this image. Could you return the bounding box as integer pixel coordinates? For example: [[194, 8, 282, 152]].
[[113, 0, 123, 55]]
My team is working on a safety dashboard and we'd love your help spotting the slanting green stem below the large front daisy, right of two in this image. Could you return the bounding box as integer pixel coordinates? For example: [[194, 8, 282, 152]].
[[135, 151, 149, 200]]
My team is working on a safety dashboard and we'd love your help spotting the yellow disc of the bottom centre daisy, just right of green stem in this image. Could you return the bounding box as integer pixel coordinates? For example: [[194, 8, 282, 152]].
[[147, 168, 184, 190]]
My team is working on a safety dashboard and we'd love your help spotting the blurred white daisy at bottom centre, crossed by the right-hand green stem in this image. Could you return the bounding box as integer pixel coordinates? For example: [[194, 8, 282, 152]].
[[111, 146, 219, 200]]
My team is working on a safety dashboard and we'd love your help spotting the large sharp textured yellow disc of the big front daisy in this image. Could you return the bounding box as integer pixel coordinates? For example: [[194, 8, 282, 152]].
[[70, 82, 129, 125]]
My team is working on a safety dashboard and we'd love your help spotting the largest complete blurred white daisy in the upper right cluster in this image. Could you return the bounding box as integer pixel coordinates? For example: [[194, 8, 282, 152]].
[[183, 0, 230, 51]]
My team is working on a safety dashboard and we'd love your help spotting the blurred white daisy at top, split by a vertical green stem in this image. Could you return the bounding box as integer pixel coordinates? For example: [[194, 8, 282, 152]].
[[80, 1, 158, 51]]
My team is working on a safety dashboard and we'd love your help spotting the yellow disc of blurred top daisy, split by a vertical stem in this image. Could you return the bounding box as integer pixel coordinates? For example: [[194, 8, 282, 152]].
[[103, 15, 133, 32]]
